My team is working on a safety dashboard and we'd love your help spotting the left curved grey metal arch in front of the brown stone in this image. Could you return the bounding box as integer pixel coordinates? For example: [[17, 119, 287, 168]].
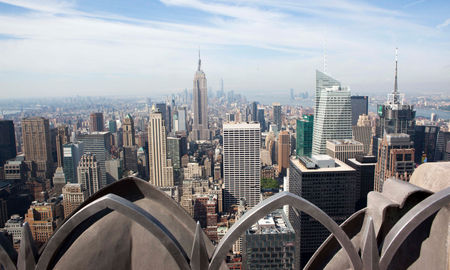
[[36, 194, 190, 269]]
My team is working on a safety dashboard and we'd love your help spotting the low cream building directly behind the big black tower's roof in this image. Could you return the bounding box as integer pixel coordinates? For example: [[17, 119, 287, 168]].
[[327, 140, 364, 162]]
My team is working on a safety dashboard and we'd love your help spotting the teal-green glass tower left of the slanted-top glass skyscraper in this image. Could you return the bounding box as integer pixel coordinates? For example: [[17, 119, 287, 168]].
[[296, 115, 314, 157]]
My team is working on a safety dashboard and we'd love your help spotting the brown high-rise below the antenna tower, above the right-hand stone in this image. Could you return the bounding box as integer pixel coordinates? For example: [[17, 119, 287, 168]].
[[374, 133, 414, 192]]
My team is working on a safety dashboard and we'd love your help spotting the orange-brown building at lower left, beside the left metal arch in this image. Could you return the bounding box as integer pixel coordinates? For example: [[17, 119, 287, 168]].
[[25, 202, 56, 246]]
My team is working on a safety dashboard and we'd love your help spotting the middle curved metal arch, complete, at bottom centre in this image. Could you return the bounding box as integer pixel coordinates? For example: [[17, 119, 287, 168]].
[[209, 191, 362, 270]]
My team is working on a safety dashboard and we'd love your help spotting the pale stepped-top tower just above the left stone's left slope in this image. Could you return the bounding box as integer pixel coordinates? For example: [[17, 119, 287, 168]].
[[77, 153, 101, 196]]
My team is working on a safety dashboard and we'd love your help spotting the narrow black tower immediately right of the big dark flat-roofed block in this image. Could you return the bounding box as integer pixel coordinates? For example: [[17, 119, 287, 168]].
[[346, 155, 377, 211]]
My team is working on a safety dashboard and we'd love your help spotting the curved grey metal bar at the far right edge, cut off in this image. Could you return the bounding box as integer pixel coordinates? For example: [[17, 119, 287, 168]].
[[380, 187, 450, 270]]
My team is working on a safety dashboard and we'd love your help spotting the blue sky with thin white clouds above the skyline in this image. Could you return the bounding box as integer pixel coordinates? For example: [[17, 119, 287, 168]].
[[0, 0, 450, 98]]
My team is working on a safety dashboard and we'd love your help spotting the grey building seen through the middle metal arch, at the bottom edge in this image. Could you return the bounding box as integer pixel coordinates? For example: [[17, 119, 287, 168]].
[[242, 210, 298, 270]]
